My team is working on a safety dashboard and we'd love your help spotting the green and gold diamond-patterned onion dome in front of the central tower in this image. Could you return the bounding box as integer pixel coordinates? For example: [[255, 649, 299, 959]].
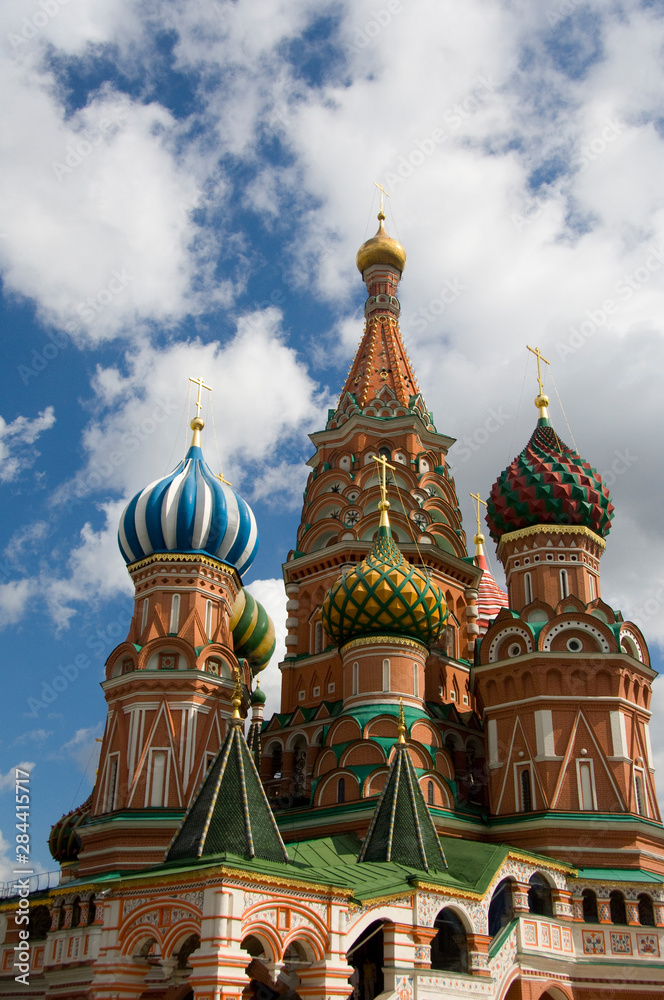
[[322, 500, 447, 646]]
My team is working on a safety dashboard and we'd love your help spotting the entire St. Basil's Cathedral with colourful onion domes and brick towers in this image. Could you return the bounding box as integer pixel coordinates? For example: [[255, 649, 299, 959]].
[[0, 210, 664, 1000]]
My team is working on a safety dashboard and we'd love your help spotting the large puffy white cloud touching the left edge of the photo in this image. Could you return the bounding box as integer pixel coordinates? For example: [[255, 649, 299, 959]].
[[0, 60, 232, 344]]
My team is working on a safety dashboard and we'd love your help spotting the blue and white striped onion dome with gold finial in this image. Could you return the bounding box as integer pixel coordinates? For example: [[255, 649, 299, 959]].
[[118, 419, 258, 575]]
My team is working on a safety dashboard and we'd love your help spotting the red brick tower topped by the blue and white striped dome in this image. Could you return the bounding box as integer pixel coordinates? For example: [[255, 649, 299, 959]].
[[54, 391, 274, 877]]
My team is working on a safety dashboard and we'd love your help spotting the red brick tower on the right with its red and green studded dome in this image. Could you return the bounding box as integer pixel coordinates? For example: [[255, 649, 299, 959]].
[[473, 372, 664, 870]]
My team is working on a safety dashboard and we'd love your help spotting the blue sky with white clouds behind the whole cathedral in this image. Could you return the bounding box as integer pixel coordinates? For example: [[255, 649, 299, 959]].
[[0, 0, 664, 880]]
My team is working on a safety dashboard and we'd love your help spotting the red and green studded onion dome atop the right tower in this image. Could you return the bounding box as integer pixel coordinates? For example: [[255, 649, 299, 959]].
[[486, 412, 613, 542]]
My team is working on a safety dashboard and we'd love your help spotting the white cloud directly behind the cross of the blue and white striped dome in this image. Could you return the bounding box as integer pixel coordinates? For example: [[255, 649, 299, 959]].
[[56, 308, 329, 502]]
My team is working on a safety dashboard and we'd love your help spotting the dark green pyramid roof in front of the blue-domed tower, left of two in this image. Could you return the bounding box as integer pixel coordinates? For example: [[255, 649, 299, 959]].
[[166, 723, 288, 861]]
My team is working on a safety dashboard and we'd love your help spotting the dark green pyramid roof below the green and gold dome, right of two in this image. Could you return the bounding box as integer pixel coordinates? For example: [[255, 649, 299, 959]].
[[357, 743, 447, 872]]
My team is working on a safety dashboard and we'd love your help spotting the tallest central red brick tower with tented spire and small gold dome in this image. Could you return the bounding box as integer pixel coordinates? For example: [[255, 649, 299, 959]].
[[261, 210, 488, 835]]
